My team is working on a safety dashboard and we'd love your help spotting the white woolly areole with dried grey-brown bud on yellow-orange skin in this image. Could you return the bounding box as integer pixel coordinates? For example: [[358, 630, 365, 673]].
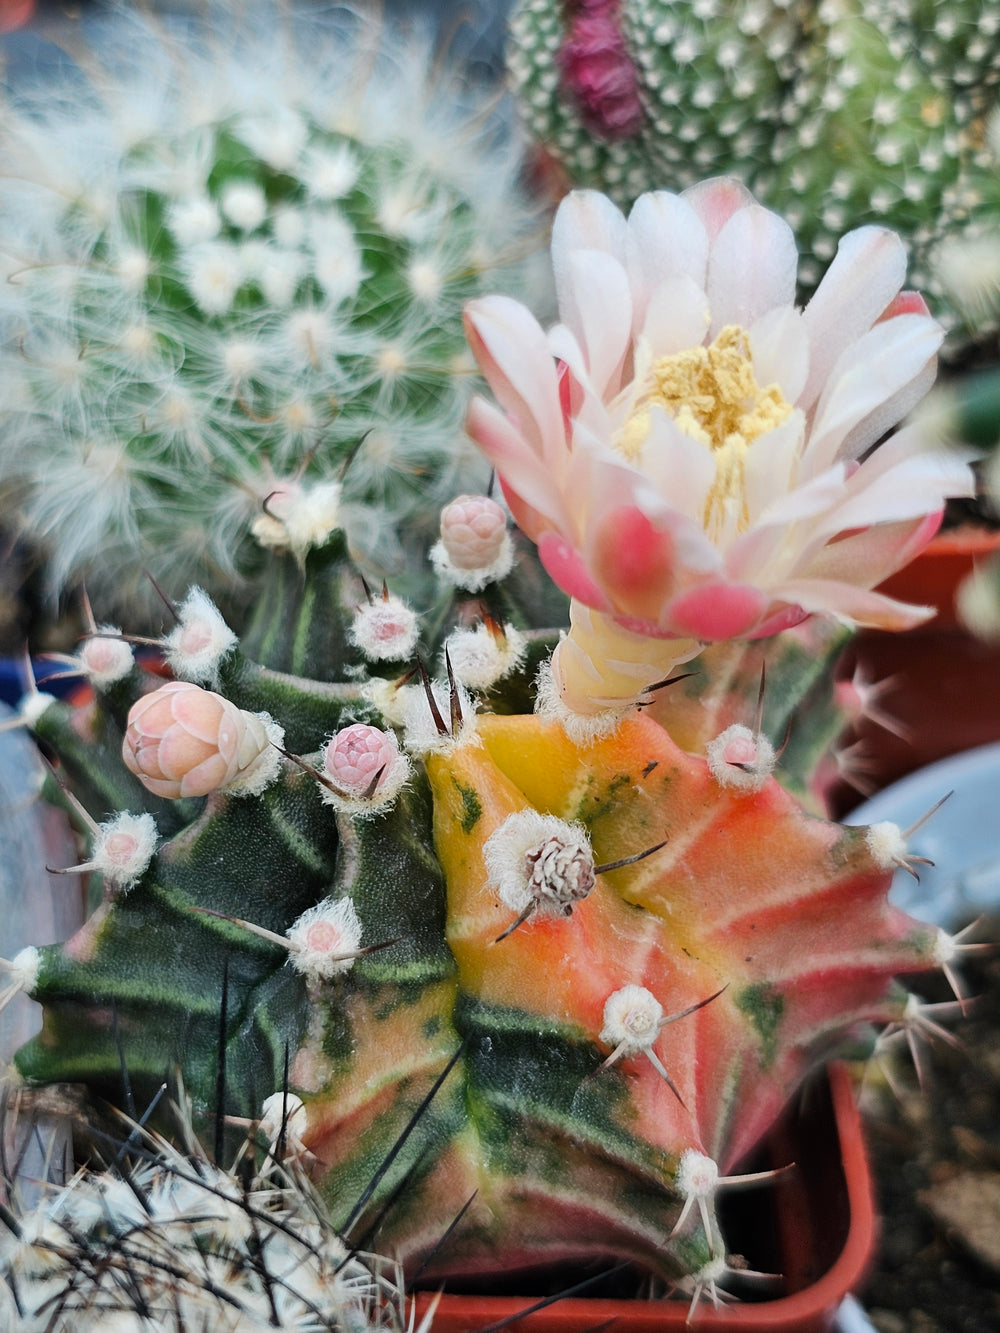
[[483, 809, 596, 916]]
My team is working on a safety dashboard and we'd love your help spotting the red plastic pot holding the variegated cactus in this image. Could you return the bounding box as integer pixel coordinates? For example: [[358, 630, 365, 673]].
[[417, 1065, 876, 1333]]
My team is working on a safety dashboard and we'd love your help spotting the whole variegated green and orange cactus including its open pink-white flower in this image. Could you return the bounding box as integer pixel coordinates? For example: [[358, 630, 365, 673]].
[[0, 181, 971, 1311]]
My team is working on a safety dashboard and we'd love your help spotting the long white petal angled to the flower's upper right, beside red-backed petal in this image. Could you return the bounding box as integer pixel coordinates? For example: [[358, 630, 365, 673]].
[[800, 227, 907, 408]]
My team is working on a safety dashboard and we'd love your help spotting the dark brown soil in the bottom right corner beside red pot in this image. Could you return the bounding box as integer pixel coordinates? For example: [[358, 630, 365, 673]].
[[859, 918, 1000, 1333]]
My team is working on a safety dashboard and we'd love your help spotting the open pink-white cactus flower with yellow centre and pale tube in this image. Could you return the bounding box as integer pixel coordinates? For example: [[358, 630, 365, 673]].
[[467, 179, 972, 713]]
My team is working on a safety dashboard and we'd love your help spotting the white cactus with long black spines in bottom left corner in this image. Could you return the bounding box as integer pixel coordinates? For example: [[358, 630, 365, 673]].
[[0, 1094, 425, 1333]]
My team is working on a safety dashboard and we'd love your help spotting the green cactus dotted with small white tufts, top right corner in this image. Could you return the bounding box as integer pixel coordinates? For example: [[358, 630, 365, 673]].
[[508, 0, 1000, 335]]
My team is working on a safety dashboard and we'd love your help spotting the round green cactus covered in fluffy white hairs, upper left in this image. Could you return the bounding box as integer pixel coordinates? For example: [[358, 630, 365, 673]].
[[0, 5, 543, 618]]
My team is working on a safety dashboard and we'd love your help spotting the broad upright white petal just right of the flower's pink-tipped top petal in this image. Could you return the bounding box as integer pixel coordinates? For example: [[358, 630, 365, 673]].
[[708, 204, 799, 337]]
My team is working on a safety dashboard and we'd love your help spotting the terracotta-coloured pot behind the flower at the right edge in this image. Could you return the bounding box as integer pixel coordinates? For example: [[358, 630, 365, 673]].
[[835, 528, 1000, 813]]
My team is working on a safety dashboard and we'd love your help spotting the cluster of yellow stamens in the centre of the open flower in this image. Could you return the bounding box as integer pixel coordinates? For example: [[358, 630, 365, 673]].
[[616, 324, 792, 537]]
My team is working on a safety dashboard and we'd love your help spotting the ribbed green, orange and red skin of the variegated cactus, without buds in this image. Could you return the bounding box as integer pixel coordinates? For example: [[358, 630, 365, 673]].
[[7, 543, 940, 1295]]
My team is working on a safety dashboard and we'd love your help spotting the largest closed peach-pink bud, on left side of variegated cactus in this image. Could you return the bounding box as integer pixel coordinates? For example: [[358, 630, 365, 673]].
[[121, 680, 283, 800]]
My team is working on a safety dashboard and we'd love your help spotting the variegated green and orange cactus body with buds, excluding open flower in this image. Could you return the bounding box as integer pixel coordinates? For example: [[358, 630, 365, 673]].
[[8, 174, 981, 1290]]
